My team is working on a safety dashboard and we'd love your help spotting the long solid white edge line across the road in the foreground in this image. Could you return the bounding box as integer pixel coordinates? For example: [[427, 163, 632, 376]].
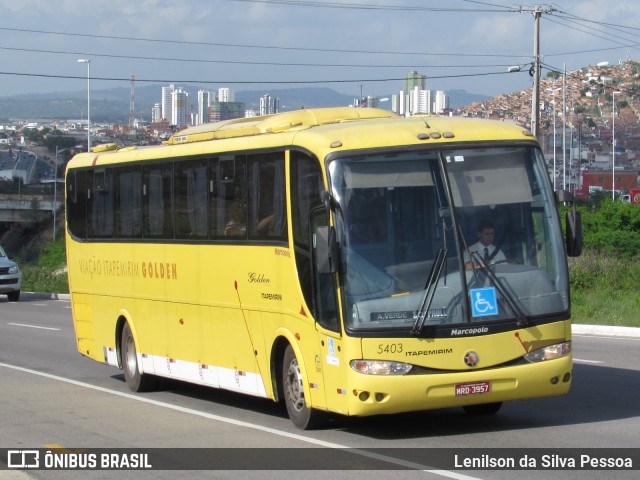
[[0, 363, 480, 480]]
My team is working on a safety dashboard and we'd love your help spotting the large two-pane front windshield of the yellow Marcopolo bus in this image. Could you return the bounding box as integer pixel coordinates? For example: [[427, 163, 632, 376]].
[[329, 146, 569, 336]]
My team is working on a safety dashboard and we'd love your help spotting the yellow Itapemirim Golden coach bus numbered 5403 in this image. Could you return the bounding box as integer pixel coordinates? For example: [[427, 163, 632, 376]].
[[66, 108, 581, 428]]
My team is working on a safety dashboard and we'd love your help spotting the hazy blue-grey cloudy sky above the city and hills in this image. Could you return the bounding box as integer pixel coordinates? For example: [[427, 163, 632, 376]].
[[0, 0, 640, 98]]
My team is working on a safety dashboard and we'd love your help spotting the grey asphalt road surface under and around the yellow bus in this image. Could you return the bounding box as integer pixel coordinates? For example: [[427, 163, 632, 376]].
[[0, 296, 640, 480]]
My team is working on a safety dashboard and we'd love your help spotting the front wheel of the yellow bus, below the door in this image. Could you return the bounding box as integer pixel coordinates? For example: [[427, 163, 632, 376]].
[[282, 345, 323, 430]]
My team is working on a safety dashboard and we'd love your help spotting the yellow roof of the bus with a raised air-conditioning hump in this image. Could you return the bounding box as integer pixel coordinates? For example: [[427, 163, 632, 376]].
[[66, 107, 536, 166]]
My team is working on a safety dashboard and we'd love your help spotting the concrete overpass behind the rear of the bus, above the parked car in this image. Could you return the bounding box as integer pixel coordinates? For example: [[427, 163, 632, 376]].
[[0, 192, 64, 223]]
